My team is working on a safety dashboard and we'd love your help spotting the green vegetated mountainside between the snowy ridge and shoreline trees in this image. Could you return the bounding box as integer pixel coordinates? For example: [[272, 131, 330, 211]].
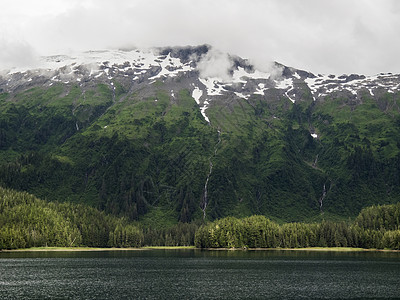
[[0, 79, 400, 225]]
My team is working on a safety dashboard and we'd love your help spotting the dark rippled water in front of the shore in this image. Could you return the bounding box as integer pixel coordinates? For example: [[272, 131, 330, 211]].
[[0, 250, 400, 299]]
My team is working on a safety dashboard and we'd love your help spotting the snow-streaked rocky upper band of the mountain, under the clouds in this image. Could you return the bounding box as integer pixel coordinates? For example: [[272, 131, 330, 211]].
[[0, 45, 400, 122]]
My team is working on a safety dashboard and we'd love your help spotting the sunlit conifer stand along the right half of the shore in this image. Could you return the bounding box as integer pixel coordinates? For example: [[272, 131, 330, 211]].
[[195, 214, 400, 250]]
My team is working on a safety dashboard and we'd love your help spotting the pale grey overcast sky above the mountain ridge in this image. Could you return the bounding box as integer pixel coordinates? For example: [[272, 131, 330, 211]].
[[0, 0, 400, 75]]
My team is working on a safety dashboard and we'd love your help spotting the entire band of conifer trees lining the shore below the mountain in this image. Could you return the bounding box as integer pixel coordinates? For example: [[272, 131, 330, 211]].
[[0, 188, 400, 250]]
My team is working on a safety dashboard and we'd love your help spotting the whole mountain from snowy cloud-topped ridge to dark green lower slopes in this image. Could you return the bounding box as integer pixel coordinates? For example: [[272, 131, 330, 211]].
[[0, 45, 400, 224]]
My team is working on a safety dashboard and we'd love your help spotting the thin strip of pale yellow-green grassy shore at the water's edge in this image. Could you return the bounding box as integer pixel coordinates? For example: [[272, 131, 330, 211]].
[[0, 246, 400, 253]]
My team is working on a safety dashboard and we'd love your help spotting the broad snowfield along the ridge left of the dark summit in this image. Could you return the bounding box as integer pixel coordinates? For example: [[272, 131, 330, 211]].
[[3, 50, 194, 82]]
